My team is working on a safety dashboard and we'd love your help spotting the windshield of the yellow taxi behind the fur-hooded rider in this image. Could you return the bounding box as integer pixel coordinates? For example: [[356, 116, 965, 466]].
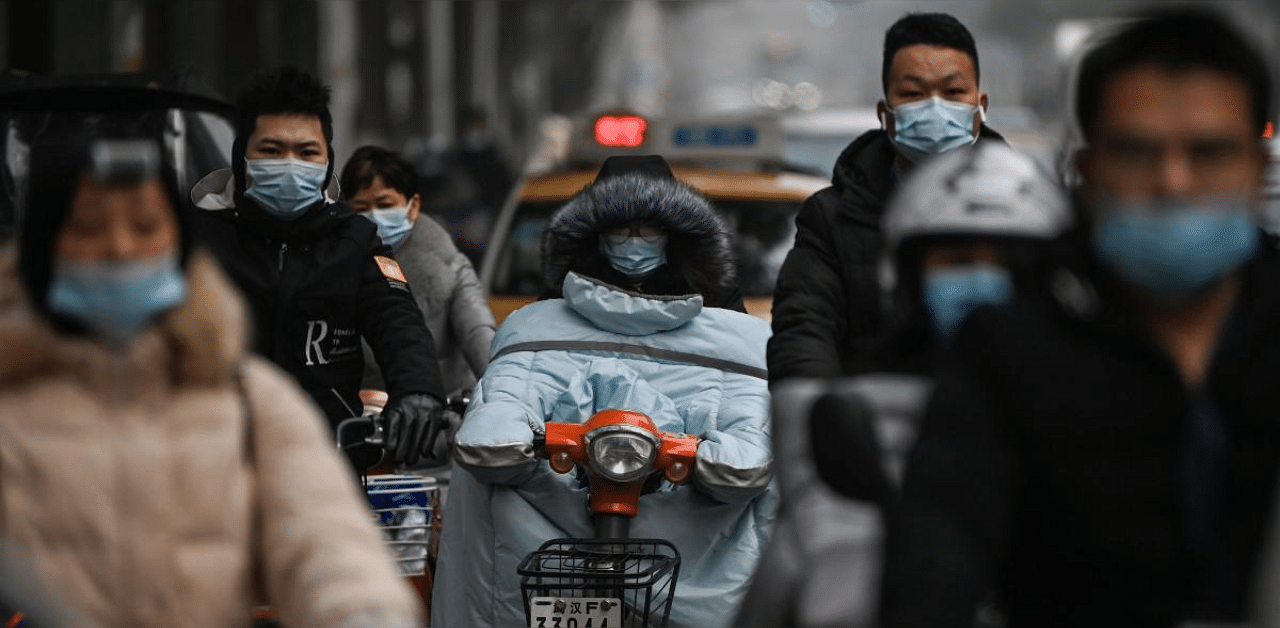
[[490, 200, 800, 298]]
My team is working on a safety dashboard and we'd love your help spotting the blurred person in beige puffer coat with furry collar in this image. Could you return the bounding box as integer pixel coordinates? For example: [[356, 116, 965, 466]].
[[0, 141, 421, 627]]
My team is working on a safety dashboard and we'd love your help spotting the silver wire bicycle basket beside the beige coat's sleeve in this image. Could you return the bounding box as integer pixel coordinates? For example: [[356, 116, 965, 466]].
[[365, 475, 440, 576]]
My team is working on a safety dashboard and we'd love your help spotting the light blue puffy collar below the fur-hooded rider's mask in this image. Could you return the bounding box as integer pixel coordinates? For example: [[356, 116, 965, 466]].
[[563, 272, 703, 336]]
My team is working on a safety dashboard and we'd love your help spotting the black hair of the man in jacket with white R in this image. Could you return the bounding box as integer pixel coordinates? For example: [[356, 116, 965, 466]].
[[232, 67, 333, 192]]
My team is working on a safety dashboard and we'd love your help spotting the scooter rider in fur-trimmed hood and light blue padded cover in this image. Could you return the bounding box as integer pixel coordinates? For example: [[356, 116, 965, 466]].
[[431, 157, 777, 625]]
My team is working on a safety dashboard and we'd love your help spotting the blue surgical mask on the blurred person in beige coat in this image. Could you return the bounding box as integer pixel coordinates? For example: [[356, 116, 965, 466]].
[[49, 253, 187, 344]]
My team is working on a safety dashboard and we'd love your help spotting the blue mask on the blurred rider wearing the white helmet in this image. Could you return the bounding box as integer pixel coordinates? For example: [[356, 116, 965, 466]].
[[923, 263, 1014, 340]]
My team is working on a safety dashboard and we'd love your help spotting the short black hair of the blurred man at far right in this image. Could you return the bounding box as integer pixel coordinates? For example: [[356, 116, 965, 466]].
[[1075, 6, 1271, 139]]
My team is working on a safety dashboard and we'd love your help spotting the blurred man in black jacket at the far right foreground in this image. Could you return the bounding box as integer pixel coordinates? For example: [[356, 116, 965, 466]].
[[884, 8, 1280, 628]]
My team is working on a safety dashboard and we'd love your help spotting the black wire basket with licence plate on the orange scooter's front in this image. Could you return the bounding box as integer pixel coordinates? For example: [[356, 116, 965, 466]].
[[517, 538, 680, 628]]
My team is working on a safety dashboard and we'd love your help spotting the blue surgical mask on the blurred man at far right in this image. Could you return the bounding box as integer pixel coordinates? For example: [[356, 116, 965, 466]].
[[1093, 200, 1258, 303]]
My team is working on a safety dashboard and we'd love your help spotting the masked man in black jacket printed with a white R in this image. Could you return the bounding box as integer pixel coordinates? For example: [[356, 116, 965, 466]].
[[191, 68, 445, 466]]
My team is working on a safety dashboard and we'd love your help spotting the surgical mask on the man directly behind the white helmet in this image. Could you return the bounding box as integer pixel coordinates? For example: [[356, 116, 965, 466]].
[[890, 96, 986, 162]]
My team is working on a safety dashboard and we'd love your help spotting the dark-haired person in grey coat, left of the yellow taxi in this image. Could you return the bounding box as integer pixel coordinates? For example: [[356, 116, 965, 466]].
[[339, 146, 497, 394]]
